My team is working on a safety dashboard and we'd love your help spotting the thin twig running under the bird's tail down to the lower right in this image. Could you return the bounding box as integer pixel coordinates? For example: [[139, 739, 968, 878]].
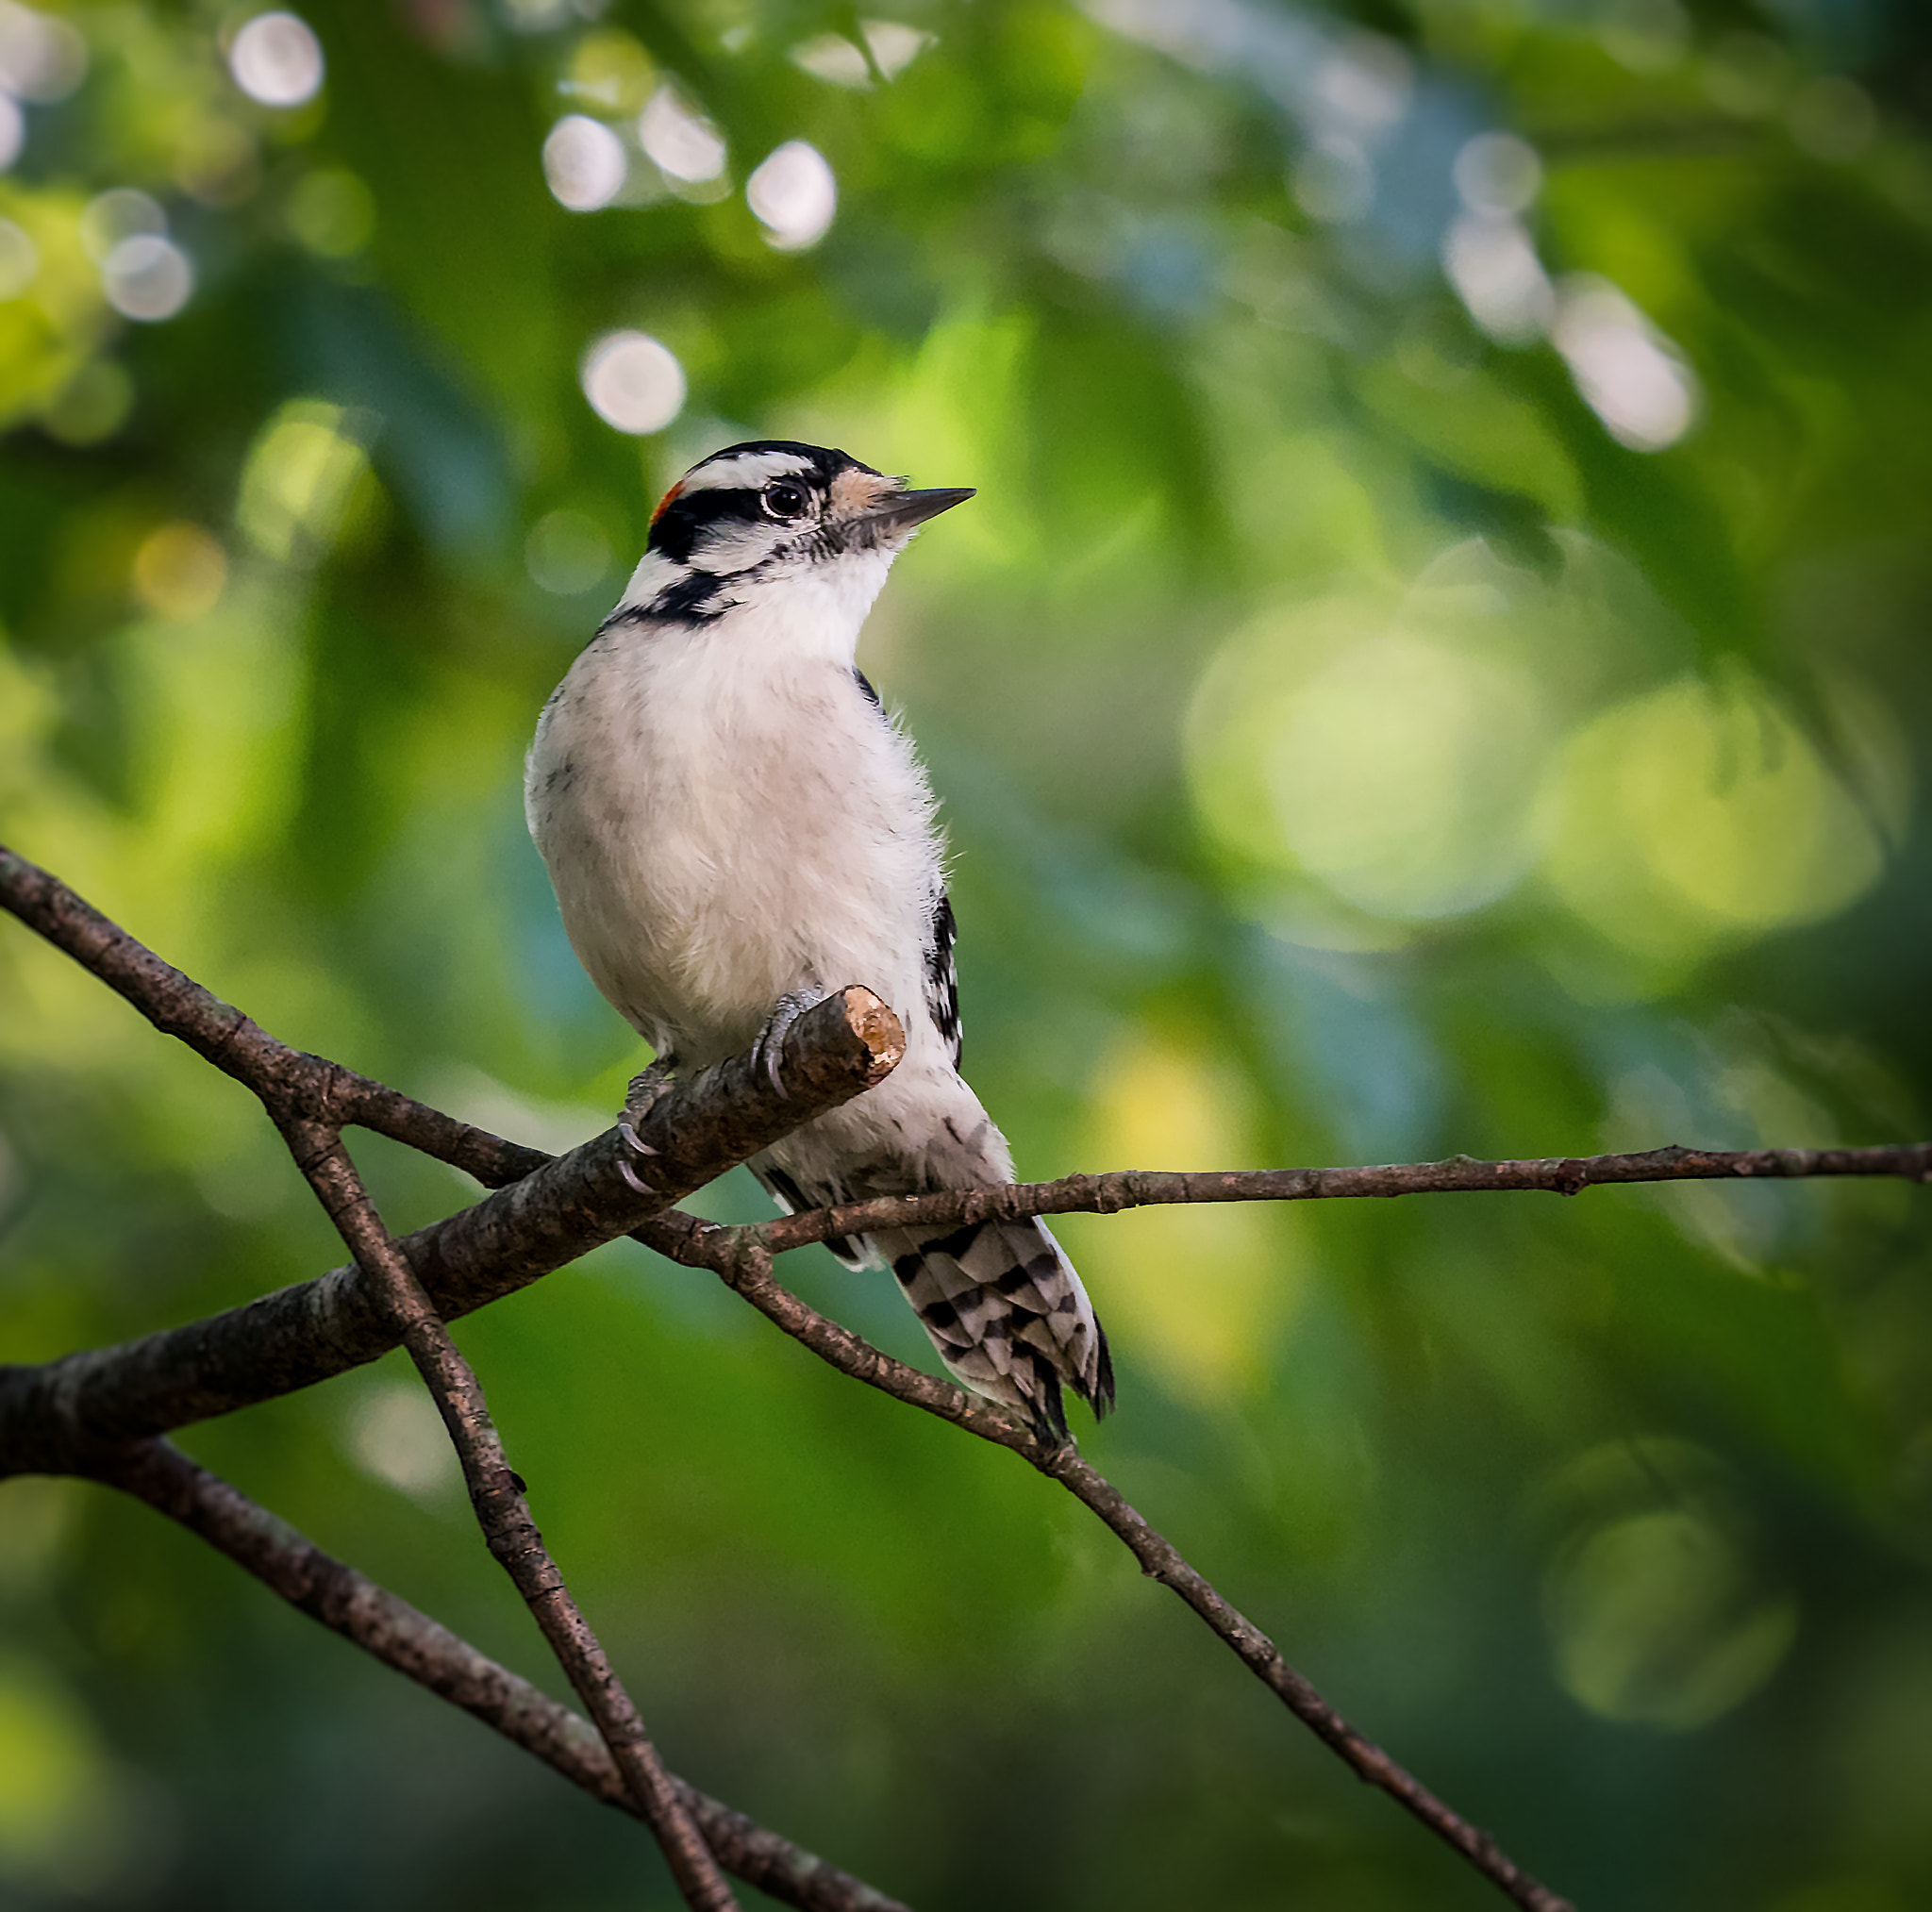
[[651, 1217, 1573, 1912]]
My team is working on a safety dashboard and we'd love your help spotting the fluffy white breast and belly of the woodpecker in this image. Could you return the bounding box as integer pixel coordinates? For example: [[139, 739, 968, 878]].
[[525, 594, 941, 1066]]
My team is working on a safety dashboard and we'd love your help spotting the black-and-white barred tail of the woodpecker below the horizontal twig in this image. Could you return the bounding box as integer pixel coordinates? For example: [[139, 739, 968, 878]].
[[872, 1219, 1113, 1442]]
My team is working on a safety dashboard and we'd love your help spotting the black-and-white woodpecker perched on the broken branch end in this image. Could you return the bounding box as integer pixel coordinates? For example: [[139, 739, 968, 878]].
[[524, 439, 1115, 1445]]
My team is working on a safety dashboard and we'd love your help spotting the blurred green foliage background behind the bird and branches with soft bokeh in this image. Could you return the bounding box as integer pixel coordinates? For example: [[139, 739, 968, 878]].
[[0, 0, 1932, 1912]]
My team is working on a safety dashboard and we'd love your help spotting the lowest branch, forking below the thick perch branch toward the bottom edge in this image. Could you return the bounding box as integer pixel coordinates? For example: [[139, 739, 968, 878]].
[[83, 1440, 908, 1912]]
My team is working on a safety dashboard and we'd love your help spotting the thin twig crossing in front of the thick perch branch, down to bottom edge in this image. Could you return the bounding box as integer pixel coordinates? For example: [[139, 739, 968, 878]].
[[278, 1121, 738, 1912]]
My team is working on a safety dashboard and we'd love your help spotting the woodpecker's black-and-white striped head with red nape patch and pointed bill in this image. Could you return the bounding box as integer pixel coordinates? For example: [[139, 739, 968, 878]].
[[612, 439, 972, 636]]
